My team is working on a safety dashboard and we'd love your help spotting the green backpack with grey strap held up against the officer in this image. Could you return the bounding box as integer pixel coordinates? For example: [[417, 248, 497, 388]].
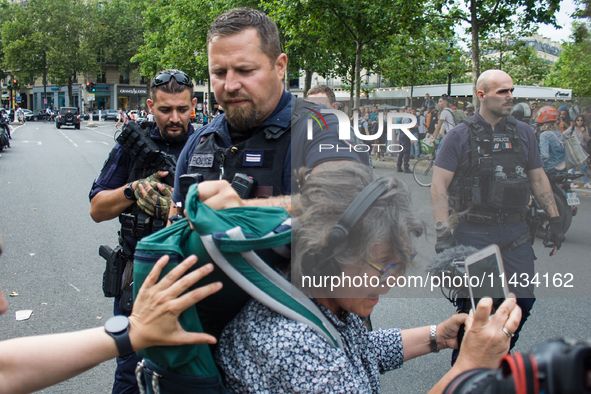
[[134, 187, 342, 388]]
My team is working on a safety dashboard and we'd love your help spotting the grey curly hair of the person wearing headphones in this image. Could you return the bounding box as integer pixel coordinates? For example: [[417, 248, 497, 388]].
[[291, 162, 425, 294]]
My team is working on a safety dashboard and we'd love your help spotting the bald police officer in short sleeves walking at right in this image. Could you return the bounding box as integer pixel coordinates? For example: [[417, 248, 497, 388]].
[[431, 70, 565, 358]]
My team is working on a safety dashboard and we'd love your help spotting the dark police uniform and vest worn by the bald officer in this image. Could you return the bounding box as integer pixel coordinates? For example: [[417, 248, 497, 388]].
[[435, 112, 542, 347]]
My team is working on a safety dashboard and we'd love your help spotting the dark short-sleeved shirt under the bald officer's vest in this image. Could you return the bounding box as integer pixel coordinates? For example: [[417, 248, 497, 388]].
[[435, 111, 542, 173]]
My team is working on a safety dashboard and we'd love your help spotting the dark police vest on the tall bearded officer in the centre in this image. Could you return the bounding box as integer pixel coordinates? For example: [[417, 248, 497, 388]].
[[188, 126, 291, 197]]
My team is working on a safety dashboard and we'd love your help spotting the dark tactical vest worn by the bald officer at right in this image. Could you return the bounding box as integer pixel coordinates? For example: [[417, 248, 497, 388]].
[[448, 116, 530, 215]]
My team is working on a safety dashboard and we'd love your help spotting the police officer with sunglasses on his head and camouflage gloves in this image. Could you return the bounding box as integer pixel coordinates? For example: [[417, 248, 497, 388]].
[[90, 70, 196, 393]]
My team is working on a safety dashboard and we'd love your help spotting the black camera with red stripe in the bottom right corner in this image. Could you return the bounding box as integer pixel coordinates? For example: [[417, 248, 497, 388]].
[[444, 340, 591, 394]]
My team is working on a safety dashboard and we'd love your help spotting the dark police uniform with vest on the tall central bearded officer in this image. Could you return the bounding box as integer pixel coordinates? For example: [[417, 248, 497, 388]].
[[172, 92, 359, 346]]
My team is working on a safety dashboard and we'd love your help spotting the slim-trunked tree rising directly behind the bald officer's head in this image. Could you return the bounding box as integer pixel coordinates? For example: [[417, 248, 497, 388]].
[[432, 0, 560, 104]]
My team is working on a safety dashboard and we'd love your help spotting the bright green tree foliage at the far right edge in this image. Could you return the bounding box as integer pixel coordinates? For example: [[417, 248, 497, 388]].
[[544, 24, 591, 97]]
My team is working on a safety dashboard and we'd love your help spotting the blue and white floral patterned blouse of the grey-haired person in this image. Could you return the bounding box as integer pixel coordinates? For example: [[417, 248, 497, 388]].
[[216, 300, 404, 393]]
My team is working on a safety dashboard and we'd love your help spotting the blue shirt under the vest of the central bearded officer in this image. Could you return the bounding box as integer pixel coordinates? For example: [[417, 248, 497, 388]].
[[172, 91, 359, 201]]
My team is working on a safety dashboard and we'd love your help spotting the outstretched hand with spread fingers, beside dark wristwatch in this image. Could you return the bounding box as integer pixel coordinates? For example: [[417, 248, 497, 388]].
[[129, 256, 222, 351]]
